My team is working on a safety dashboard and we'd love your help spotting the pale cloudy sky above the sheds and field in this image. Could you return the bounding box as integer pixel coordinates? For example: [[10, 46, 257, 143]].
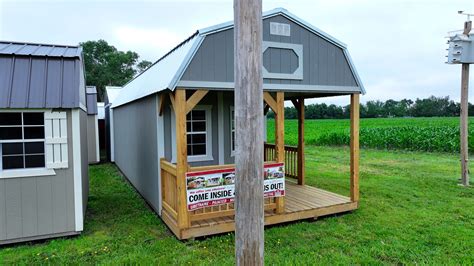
[[0, 0, 474, 104]]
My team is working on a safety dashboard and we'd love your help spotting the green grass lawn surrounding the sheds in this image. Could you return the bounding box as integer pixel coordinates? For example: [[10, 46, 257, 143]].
[[0, 146, 474, 265]]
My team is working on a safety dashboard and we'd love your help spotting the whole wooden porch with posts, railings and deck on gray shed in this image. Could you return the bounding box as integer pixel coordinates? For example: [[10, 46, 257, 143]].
[[159, 89, 359, 239]]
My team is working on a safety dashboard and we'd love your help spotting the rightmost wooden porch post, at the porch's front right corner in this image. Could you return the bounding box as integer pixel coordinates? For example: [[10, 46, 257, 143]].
[[350, 94, 359, 202]]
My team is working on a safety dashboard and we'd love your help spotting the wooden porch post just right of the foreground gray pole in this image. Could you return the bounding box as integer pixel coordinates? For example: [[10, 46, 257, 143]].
[[275, 91, 285, 213]]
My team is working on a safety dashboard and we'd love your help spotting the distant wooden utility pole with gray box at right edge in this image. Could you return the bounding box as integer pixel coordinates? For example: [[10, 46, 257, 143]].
[[460, 21, 472, 186]]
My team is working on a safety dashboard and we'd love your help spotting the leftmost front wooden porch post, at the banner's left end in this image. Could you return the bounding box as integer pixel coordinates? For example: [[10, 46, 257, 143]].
[[173, 89, 190, 229]]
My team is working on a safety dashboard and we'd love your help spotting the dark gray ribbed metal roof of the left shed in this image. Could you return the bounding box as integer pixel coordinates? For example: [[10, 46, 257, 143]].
[[0, 41, 86, 110]]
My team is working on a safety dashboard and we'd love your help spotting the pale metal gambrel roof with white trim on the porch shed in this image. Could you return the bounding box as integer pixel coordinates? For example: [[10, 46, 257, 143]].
[[112, 8, 365, 108]]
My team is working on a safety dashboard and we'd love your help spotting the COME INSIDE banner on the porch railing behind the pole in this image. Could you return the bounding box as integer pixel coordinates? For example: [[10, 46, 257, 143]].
[[186, 163, 285, 211]]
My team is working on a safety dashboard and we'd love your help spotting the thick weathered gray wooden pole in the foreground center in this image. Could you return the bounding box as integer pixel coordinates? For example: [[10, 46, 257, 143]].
[[234, 0, 264, 265]]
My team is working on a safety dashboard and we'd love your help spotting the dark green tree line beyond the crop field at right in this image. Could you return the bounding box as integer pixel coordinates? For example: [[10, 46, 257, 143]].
[[268, 96, 474, 119]]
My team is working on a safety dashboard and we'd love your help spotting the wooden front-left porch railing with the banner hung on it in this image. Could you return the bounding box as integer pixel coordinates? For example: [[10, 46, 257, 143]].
[[161, 158, 277, 227]]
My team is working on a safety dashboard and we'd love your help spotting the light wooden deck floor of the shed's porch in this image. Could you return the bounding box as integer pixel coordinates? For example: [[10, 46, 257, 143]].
[[164, 181, 358, 239]]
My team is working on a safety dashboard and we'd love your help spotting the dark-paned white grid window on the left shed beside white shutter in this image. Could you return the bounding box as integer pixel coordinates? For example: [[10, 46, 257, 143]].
[[0, 112, 45, 171]]
